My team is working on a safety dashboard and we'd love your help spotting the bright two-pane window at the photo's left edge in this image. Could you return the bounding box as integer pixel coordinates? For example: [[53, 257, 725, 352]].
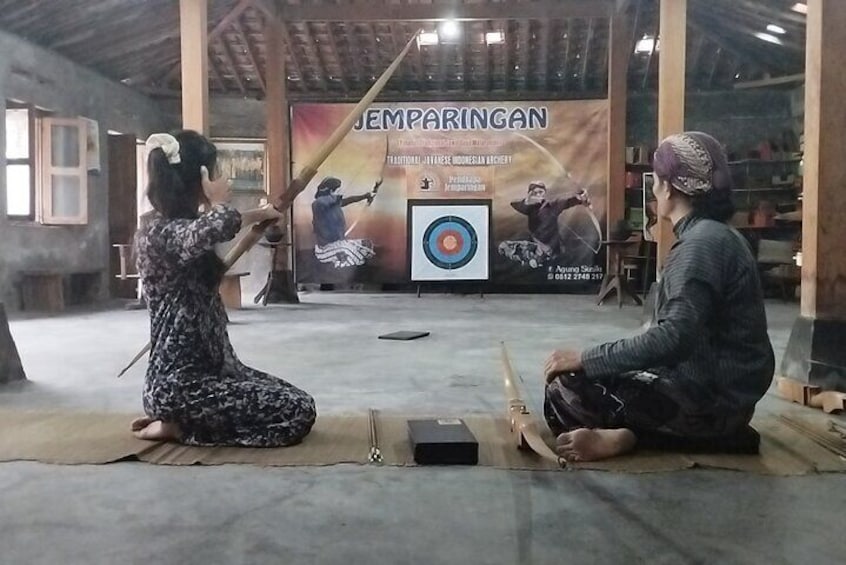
[[6, 102, 36, 221]]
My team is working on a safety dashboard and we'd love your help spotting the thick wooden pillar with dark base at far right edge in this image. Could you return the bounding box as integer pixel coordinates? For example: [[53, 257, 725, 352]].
[[780, 0, 846, 392]]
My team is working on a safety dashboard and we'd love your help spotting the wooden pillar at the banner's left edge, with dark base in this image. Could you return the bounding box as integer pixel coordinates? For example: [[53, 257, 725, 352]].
[[265, 14, 299, 303]]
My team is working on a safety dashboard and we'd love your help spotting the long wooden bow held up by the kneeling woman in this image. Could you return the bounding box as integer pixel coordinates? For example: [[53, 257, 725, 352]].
[[118, 29, 423, 377]]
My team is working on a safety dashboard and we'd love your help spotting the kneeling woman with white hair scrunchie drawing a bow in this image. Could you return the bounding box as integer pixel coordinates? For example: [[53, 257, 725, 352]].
[[132, 131, 316, 447]]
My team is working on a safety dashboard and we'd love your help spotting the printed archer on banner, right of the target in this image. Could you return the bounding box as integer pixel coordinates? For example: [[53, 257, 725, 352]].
[[499, 181, 590, 269]]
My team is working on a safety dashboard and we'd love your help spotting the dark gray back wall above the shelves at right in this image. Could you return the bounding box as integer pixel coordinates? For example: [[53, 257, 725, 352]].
[[626, 89, 794, 158]]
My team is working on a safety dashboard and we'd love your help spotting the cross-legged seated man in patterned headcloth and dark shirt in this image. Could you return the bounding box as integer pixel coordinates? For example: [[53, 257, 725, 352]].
[[544, 132, 775, 461]]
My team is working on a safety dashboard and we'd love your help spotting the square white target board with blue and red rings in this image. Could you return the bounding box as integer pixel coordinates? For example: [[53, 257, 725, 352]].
[[408, 200, 491, 281]]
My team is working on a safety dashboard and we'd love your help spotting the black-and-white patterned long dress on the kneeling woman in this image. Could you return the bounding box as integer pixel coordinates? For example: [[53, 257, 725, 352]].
[[136, 205, 316, 447]]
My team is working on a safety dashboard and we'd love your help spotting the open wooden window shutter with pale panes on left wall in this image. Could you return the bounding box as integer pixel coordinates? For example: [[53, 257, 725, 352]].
[[38, 118, 88, 224]]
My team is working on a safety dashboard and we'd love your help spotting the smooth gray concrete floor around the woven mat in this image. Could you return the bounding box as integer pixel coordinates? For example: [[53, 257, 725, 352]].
[[0, 293, 846, 565]]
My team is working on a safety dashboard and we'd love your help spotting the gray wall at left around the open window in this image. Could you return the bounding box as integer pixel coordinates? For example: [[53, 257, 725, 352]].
[[0, 31, 173, 310]]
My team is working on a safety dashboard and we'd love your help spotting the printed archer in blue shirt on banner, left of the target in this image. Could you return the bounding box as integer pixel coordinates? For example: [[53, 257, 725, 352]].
[[311, 177, 382, 269]]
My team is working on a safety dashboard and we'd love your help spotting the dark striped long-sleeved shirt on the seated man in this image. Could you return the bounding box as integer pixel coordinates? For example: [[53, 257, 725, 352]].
[[582, 214, 775, 412]]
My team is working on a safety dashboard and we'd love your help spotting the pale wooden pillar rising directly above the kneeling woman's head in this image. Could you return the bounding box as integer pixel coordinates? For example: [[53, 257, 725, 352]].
[[179, 0, 209, 135]]
